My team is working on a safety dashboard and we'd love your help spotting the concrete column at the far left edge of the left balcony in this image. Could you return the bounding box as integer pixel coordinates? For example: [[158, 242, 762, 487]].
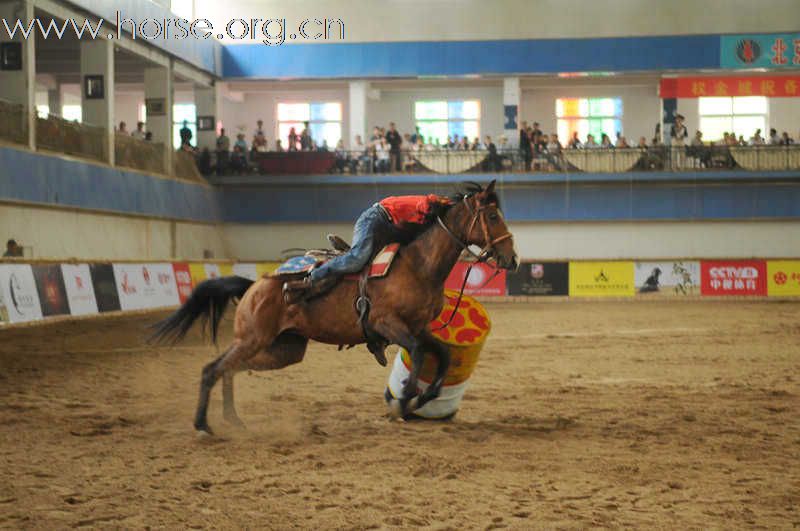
[[0, 0, 36, 149]]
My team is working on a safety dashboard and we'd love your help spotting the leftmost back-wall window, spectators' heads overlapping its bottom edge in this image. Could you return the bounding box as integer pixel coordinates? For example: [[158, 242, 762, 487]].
[[278, 101, 342, 149]]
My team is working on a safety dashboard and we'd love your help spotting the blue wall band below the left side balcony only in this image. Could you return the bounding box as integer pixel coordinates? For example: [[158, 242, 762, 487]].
[[0, 147, 220, 222]]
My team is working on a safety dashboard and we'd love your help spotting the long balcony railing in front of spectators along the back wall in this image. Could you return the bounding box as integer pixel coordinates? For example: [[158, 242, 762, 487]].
[[204, 145, 800, 176]]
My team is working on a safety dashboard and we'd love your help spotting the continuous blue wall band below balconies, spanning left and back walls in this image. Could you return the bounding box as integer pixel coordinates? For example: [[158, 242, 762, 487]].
[[0, 147, 800, 223]]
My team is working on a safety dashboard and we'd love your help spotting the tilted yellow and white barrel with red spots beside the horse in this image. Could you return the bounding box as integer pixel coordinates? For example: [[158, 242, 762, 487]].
[[384, 290, 492, 419]]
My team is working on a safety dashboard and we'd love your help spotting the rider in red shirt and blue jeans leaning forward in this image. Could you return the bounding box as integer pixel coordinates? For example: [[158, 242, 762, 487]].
[[284, 194, 451, 299]]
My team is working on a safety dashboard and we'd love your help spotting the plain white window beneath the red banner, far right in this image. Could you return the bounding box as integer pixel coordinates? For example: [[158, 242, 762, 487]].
[[697, 96, 767, 141]]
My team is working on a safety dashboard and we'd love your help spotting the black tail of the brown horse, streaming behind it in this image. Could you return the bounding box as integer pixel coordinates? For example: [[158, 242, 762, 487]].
[[150, 276, 253, 344]]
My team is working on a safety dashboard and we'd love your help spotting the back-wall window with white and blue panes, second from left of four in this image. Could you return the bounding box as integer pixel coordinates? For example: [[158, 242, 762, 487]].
[[414, 100, 481, 144]]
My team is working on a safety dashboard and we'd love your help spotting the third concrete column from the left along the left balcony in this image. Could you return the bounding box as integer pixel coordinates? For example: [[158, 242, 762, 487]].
[[144, 63, 174, 175]]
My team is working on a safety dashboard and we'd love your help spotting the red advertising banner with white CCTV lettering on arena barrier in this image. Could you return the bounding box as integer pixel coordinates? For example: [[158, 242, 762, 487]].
[[700, 260, 767, 295]]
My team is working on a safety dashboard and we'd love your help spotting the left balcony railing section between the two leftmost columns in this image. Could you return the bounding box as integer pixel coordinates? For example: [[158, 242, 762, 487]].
[[36, 114, 108, 162]]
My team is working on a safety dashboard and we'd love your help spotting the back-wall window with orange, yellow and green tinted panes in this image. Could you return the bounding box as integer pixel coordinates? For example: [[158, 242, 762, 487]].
[[556, 98, 622, 144]]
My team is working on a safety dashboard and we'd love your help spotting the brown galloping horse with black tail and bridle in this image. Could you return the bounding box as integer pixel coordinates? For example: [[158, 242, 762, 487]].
[[152, 181, 519, 434]]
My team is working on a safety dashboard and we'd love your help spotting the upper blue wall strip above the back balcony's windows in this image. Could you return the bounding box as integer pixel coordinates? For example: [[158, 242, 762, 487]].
[[222, 35, 720, 79]]
